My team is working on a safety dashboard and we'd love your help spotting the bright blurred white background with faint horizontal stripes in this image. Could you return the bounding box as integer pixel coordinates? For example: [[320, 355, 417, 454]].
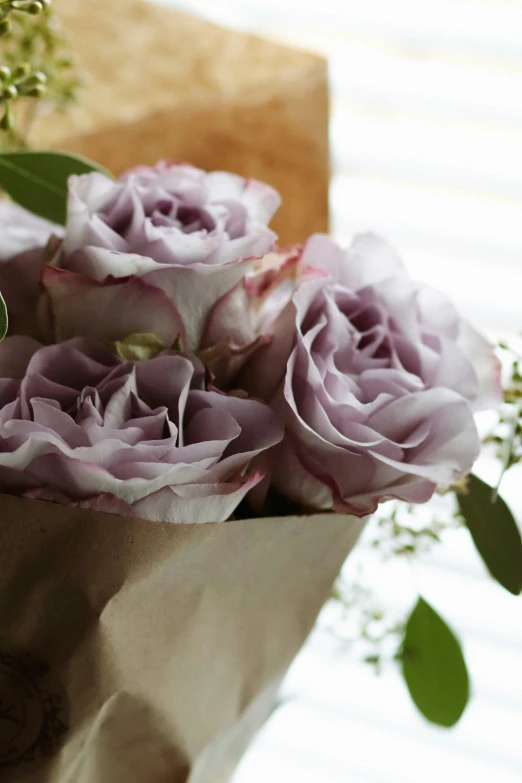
[[164, 0, 522, 783]]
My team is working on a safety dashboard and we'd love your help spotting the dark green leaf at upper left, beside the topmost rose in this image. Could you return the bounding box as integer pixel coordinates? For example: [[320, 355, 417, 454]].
[[0, 152, 107, 225]]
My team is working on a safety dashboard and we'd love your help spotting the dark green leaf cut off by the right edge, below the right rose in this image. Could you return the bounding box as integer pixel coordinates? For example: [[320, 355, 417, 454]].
[[457, 475, 522, 595]]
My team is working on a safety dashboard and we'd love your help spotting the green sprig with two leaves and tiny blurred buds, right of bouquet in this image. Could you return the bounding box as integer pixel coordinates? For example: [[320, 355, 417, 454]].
[[333, 343, 522, 726]]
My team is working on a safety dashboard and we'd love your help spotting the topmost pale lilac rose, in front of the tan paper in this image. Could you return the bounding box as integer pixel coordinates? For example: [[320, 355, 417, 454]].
[[44, 162, 280, 349]]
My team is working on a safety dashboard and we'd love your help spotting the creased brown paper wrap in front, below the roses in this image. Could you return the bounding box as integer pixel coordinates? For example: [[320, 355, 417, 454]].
[[0, 495, 364, 783]]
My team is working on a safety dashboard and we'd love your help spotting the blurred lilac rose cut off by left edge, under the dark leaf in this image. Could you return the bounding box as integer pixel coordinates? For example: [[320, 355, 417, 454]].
[[0, 200, 63, 334]]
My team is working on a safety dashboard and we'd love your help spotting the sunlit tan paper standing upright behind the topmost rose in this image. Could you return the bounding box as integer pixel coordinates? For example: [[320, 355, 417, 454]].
[[32, 0, 329, 244]]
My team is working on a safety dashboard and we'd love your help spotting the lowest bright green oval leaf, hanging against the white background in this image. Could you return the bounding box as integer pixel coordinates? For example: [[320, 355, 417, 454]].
[[401, 596, 469, 727]]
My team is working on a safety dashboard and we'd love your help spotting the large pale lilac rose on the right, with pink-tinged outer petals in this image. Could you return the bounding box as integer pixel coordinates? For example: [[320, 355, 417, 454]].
[[225, 235, 499, 515]]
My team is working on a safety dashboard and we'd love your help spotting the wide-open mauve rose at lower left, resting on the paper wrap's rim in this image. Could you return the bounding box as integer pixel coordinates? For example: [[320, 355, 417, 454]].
[[0, 337, 282, 523]]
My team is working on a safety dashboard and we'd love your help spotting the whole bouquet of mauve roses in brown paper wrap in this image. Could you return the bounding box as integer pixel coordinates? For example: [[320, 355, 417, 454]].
[[0, 153, 499, 783]]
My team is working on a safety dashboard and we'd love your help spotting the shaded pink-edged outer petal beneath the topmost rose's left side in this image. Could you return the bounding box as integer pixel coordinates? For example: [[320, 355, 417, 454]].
[[43, 266, 183, 346]]
